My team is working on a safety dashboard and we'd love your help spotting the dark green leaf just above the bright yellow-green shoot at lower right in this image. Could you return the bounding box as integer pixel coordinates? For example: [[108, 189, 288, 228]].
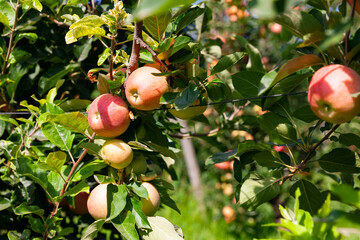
[[289, 179, 325, 215]]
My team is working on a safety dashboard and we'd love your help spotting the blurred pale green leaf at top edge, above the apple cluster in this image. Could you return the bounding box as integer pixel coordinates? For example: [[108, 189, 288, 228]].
[[134, 0, 195, 20]]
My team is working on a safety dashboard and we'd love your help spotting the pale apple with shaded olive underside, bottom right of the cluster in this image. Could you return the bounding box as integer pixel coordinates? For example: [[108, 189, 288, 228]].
[[141, 182, 160, 216]]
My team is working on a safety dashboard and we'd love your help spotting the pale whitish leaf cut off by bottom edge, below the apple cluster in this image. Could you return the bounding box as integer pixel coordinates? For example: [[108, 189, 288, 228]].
[[141, 216, 184, 240]]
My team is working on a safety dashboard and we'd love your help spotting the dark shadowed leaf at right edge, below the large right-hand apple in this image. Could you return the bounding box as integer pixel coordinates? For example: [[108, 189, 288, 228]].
[[319, 148, 360, 173]]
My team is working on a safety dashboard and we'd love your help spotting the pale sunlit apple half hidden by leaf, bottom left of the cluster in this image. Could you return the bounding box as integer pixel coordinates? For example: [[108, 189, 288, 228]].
[[87, 184, 108, 219]]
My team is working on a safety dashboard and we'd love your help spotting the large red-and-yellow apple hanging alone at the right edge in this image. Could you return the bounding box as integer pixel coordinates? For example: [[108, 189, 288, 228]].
[[308, 64, 360, 124]]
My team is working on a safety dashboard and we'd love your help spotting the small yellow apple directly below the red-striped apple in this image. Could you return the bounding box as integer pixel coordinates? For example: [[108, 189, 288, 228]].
[[100, 139, 133, 169]]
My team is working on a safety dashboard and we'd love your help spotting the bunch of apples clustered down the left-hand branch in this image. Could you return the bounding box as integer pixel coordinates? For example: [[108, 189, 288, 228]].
[[87, 67, 174, 219]]
